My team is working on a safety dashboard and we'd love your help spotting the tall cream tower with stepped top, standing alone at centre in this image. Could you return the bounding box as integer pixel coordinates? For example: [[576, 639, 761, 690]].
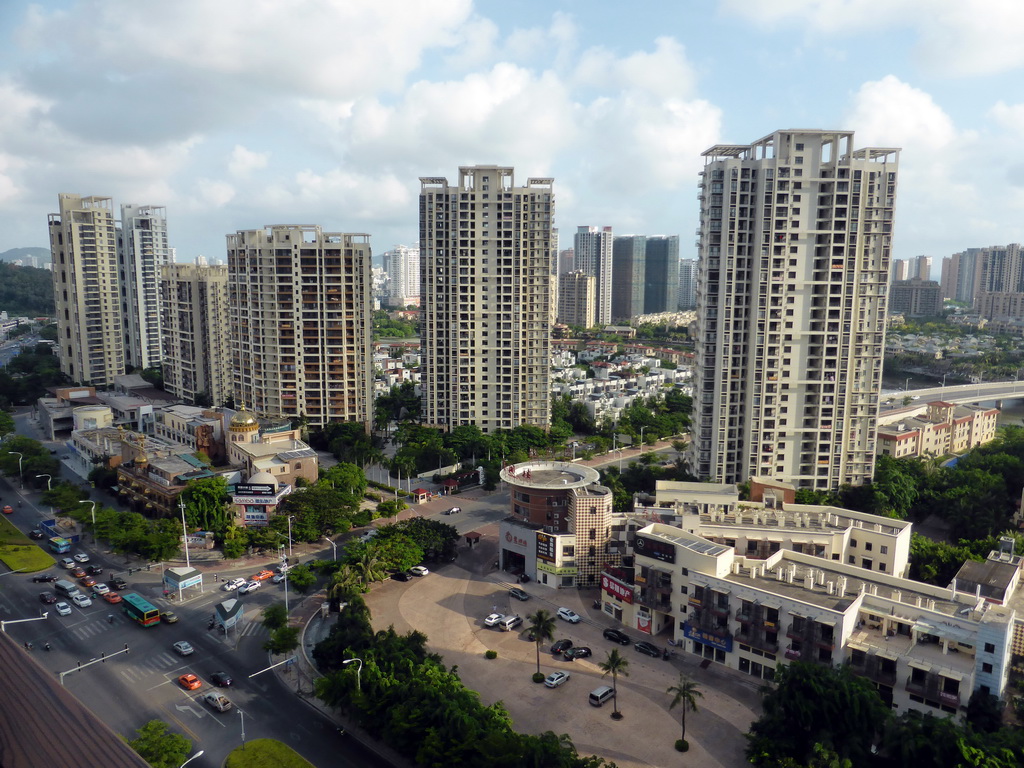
[[420, 166, 555, 432]]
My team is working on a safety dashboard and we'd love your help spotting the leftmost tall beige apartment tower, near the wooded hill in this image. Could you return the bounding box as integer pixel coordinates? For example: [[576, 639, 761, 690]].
[[49, 195, 125, 387]]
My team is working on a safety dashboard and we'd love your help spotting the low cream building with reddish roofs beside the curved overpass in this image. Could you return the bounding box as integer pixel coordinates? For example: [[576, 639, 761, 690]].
[[878, 400, 999, 459]]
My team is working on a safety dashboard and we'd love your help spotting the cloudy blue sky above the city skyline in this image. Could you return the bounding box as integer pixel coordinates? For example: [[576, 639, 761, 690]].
[[0, 0, 1024, 264]]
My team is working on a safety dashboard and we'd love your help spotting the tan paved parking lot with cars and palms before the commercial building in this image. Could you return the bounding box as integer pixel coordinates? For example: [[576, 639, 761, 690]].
[[367, 526, 760, 768]]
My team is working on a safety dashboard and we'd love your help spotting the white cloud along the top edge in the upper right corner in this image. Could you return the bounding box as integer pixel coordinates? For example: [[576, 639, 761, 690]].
[[722, 0, 1024, 76]]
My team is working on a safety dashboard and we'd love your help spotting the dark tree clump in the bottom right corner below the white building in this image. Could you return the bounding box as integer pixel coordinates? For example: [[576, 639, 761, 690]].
[[746, 662, 1024, 768]]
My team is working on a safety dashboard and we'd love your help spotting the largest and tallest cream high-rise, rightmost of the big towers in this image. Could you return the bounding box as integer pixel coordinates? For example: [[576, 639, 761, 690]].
[[690, 130, 899, 489]]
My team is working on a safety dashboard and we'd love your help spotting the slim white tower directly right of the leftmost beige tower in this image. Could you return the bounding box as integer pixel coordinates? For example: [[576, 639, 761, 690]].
[[118, 205, 171, 369]]
